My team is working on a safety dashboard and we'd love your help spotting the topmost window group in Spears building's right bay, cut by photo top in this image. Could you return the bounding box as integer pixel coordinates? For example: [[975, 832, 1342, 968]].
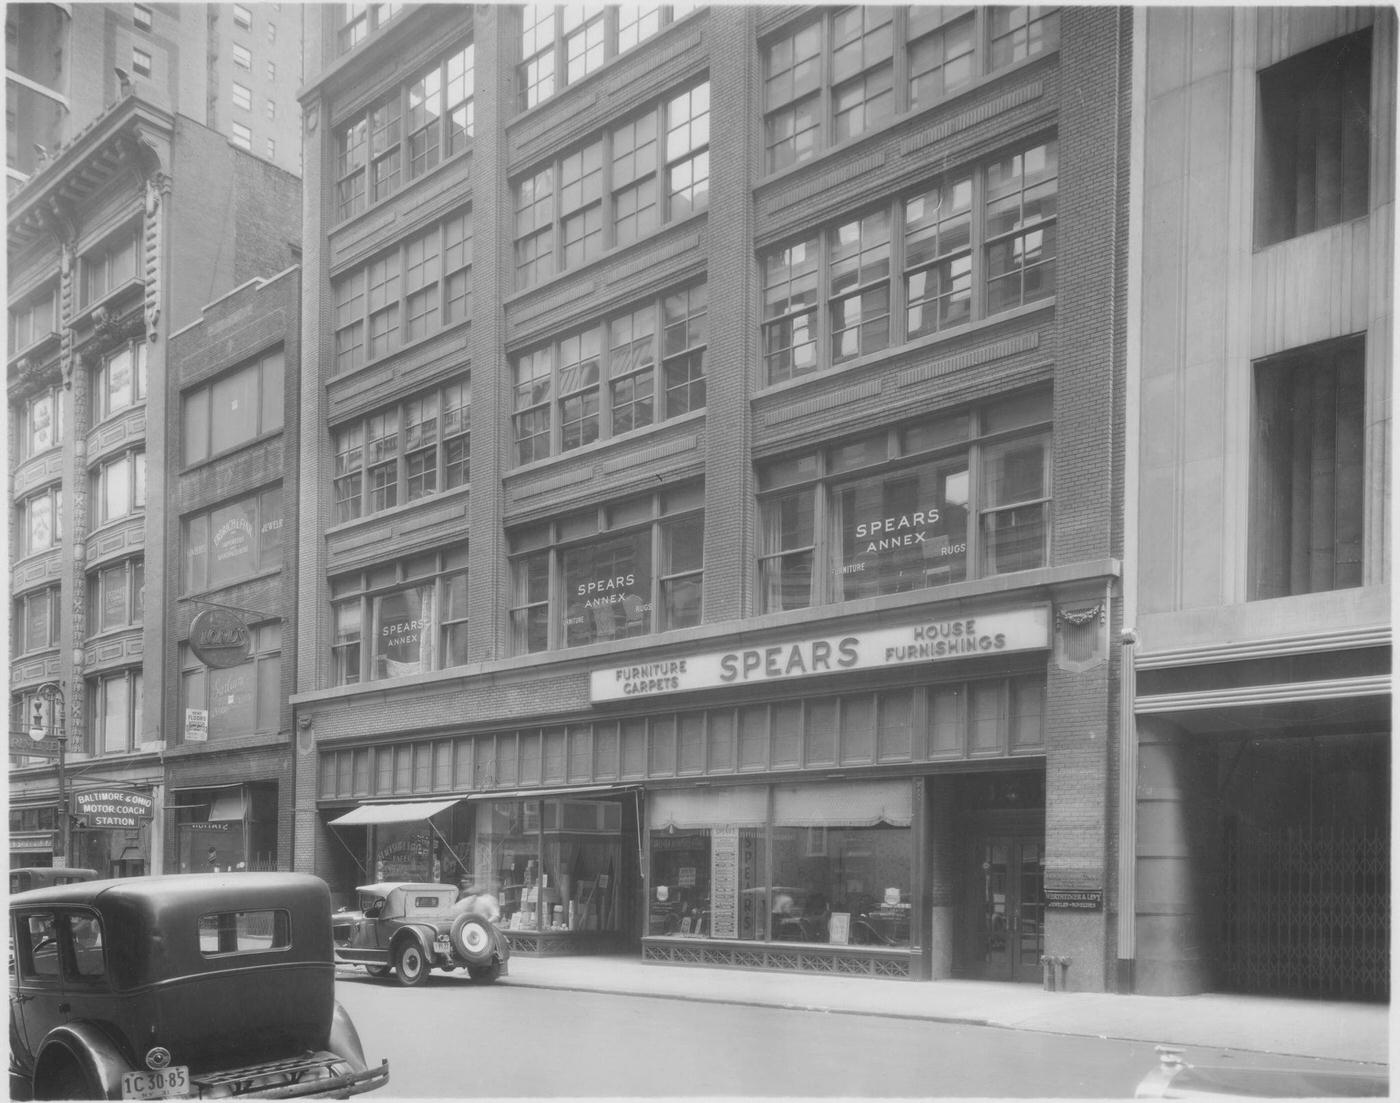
[[762, 4, 1060, 172]]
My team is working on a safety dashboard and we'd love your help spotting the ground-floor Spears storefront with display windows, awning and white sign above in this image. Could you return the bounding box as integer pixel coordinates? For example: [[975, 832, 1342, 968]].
[[319, 605, 1080, 980]]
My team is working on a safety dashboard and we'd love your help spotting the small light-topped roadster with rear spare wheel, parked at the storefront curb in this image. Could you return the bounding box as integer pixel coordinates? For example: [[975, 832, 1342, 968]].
[[333, 882, 511, 985]]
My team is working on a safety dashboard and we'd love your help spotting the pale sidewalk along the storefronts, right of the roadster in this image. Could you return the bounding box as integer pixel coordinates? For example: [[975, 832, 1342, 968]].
[[504, 956, 1390, 1064]]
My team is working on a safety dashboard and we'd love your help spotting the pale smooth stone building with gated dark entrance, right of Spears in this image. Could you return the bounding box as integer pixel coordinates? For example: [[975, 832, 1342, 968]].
[[1119, 7, 1396, 999]]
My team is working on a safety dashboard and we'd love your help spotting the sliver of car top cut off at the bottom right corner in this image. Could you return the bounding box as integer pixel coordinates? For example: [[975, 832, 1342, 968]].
[[1135, 1046, 1390, 1099]]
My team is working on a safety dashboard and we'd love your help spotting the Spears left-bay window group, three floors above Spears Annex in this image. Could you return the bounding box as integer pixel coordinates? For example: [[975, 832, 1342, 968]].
[[335, 42, 476, 220]]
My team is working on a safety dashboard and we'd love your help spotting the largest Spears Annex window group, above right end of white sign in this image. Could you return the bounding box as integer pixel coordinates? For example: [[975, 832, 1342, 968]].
[[759, 392, 1050, 612]]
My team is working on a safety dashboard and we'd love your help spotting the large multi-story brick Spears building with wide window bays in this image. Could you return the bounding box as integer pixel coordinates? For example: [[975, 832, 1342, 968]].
[[293, 4, 1133, 990]]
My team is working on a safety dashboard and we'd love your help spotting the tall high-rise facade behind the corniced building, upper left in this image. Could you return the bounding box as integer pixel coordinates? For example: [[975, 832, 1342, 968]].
[[6, 3, 302, 193]]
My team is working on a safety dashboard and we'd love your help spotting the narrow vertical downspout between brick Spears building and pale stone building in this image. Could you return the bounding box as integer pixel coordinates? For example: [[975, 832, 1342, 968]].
[[1114, 7, 1148, 992]]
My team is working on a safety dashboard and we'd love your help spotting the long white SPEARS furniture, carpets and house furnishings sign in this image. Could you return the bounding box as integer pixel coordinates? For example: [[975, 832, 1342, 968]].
[[591, 606, 1050, 703]]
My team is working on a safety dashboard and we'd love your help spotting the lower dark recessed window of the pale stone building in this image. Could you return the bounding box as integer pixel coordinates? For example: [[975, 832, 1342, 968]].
[[1249, 337, 1365, 600]]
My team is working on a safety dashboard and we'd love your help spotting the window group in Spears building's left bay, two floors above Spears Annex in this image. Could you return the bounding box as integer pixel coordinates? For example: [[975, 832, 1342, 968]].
[[332, 211, 472, 375]]
